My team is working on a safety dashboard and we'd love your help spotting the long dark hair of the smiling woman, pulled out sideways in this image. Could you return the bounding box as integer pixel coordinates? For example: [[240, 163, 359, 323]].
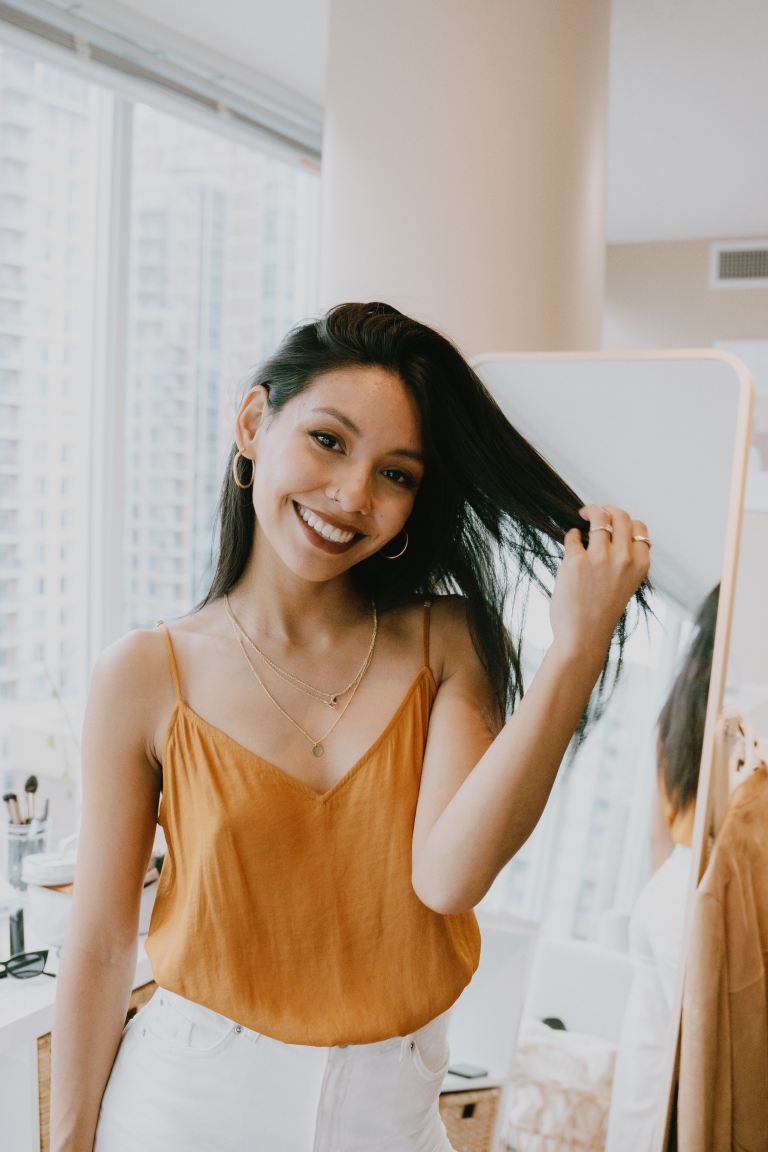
[[193, 302, 651, 743]]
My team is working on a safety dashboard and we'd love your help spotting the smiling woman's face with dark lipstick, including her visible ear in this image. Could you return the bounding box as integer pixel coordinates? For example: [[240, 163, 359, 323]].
[[238, 366, 424, 581]]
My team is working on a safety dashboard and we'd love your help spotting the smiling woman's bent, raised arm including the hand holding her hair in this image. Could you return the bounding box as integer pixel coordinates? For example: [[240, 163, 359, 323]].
[[412, 505, 648, 914]]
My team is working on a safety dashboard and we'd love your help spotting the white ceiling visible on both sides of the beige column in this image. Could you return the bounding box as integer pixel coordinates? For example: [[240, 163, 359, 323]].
[[103, 0, 768, 243]]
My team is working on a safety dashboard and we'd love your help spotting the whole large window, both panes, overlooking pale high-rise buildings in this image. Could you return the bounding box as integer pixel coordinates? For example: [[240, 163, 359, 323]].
[[0, 39, 319, 836]]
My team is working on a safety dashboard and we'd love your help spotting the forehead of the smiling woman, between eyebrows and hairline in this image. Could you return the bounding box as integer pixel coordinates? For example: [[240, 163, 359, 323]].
[[296, 365, 421, 448]]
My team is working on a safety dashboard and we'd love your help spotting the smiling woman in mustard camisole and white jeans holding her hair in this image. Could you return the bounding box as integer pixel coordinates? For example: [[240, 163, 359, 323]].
[[53, 303, 649, 1152]]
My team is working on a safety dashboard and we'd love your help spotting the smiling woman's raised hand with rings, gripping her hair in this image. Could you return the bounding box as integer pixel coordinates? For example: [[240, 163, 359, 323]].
[[549, 505, 651, 664]]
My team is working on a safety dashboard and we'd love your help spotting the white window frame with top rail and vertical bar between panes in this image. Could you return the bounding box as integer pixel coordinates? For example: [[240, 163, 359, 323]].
[[0, 22, 320, 681]]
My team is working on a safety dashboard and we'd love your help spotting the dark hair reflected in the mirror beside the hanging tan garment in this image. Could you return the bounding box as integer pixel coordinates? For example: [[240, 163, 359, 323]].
[[657, 584, 720, 813]]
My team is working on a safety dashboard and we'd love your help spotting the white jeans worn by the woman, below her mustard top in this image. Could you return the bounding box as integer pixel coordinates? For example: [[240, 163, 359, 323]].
[[93, 987, 454, 1152]]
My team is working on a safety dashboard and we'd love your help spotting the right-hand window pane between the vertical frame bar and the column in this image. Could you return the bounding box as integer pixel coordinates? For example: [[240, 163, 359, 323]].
[[123, 105, 317, 630]]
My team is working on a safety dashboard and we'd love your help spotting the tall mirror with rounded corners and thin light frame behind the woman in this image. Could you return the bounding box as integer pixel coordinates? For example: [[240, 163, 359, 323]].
[[444, 351, 752, 1152]]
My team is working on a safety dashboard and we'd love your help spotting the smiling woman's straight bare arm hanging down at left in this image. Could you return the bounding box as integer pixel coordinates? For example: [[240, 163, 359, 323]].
[[51, 631, 160, 1152]]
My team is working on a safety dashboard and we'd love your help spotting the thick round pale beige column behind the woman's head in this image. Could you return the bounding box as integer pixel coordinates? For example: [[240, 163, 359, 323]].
[[321, 0, 610, 355]]
